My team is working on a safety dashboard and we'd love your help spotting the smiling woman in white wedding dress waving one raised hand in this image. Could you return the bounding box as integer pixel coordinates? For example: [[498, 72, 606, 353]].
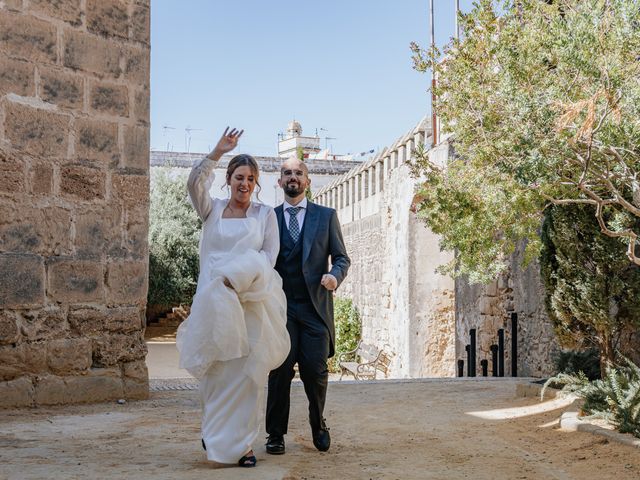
[[176, 127, 290, 467]]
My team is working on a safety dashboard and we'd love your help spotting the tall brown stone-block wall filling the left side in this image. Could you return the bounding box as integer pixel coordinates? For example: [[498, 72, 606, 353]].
[[0, 0, 149, 407]]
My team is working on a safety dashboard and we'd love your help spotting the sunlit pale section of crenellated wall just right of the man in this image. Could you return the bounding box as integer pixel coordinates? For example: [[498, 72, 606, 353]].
[[316, 121, 455, 377]]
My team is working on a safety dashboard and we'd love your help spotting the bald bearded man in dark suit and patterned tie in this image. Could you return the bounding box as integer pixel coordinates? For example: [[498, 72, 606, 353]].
[[266, 158, 351, 455]]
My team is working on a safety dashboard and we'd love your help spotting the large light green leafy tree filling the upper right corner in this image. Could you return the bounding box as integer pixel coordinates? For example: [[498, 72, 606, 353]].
[[412, 0, 640, 281]]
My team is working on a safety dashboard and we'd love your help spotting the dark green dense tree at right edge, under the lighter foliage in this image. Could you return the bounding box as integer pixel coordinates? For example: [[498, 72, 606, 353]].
[[540, 205, 640, 373]]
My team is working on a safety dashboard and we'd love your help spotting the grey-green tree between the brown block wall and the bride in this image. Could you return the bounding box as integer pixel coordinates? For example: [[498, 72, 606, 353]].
[[147, 168, 201, 308]]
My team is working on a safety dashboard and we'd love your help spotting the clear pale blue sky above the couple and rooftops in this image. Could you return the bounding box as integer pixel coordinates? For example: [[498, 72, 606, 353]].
[[151, 0, 472, 155]]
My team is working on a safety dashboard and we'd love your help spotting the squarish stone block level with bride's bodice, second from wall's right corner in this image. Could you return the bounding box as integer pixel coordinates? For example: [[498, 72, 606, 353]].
[[74, 205, 122, 257]]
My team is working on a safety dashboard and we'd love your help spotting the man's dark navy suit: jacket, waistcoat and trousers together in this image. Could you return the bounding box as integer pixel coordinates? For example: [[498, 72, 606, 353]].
[[266, 202, 350, 435]]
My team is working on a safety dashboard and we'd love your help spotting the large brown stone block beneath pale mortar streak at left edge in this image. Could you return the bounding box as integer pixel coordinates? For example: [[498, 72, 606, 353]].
[[5, 102, 69, 158]]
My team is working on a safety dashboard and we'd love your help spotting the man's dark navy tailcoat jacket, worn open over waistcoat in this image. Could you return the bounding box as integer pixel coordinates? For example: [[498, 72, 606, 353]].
[[275, 202, 351, 357]]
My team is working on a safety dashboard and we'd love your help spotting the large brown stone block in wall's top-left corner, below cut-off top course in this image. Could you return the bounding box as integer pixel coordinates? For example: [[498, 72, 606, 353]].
[[0, 10, 57, 63]]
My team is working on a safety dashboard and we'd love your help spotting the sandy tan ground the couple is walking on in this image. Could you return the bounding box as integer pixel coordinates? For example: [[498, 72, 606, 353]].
[[0, 379, 640, 480]]
